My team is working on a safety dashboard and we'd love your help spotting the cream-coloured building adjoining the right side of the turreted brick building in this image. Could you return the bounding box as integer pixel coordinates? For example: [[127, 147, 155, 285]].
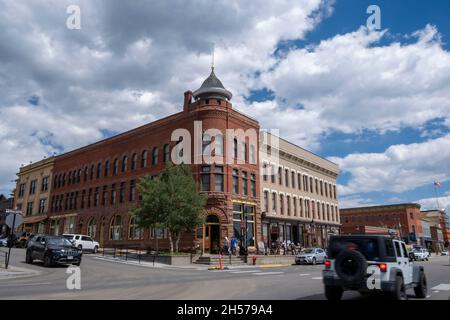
[[260, 133, 340, 247]]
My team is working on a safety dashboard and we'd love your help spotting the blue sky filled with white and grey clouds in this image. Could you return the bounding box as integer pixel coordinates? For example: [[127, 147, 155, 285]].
[[0, 0, 450, 209]]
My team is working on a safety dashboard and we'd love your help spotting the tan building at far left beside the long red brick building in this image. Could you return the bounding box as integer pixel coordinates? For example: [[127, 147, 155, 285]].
[[14, 157, 55, 233]]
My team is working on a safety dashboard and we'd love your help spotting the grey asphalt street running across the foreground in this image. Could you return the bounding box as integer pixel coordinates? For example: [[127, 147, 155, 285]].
[[0, 249, 450, 300]]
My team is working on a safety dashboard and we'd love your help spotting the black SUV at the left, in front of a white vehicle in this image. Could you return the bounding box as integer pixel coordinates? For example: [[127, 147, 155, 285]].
[[25, 235, 82, 267]]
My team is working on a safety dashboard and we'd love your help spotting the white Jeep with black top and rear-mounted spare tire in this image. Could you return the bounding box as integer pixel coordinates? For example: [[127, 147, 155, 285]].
[[323, 235, 427, 300]]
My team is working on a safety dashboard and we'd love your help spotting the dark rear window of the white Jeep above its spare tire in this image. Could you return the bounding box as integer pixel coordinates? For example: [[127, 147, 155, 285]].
[[330, 238, 380, 261]]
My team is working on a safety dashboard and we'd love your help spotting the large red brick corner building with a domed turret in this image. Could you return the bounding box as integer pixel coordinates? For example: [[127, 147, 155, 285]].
[[48, 70, 260, 252]]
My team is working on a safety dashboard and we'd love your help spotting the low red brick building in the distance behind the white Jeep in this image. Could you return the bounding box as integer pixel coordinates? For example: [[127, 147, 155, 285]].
[[339, 203, 422, 243]]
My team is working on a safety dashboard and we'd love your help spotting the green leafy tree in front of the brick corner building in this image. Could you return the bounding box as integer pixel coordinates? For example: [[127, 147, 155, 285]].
[[132, 164, 206, 253]]
